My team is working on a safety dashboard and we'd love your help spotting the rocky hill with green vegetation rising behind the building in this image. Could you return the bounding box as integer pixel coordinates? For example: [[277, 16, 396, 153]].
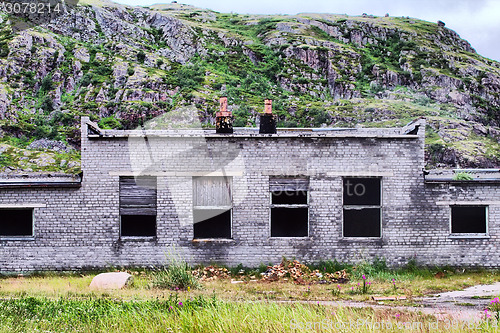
[[0, 0, 500, 172]]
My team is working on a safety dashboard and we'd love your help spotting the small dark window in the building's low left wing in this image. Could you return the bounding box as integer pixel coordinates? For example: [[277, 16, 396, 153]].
[[0, 209, 33, 236]]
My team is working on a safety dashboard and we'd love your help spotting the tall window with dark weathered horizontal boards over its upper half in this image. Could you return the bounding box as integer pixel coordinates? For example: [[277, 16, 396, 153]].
[[120, 176, 157, 237]]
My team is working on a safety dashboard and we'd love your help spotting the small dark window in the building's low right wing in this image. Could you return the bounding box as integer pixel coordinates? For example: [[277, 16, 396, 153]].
[[451, 206, 487, 234]]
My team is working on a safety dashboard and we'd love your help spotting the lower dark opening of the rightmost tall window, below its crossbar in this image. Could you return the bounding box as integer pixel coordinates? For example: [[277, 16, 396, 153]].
[[344, 208, 380, 237]]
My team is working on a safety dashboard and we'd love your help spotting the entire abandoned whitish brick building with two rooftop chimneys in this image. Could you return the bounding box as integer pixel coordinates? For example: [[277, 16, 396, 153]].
[[0, 98, 500, 271]]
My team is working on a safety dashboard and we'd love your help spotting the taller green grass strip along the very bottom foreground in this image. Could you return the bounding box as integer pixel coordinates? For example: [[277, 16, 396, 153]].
[[0, 295, 492, 333]]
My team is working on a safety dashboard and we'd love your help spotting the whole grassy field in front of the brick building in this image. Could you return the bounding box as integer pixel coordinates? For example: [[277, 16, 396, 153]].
[[0, 265, 500, 332]]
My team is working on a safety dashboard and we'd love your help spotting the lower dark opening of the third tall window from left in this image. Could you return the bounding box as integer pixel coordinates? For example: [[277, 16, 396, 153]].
[[271, 207, 308, 237]]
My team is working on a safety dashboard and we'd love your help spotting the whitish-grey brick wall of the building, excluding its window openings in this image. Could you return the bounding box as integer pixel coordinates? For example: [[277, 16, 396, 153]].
[[0, 118, 500, 271]]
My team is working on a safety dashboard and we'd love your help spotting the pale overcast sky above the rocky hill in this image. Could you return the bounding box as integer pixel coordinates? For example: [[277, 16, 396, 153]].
[[115, 0, 500, 61]]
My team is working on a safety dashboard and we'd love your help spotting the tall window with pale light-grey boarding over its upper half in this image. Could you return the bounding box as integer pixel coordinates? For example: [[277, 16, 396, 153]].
[[193, 177, 232, 238]]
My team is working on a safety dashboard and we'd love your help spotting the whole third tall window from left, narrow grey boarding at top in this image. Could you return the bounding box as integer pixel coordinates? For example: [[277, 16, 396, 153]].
[[269, 177, 309, 237]]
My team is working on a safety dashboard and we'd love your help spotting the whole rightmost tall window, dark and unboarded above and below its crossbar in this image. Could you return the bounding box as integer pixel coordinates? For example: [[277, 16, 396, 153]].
[[343, 177, 382, 237]]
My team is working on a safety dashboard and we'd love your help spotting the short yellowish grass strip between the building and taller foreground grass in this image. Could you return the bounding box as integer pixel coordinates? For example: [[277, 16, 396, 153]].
[[0, 259, 500, 302]]
